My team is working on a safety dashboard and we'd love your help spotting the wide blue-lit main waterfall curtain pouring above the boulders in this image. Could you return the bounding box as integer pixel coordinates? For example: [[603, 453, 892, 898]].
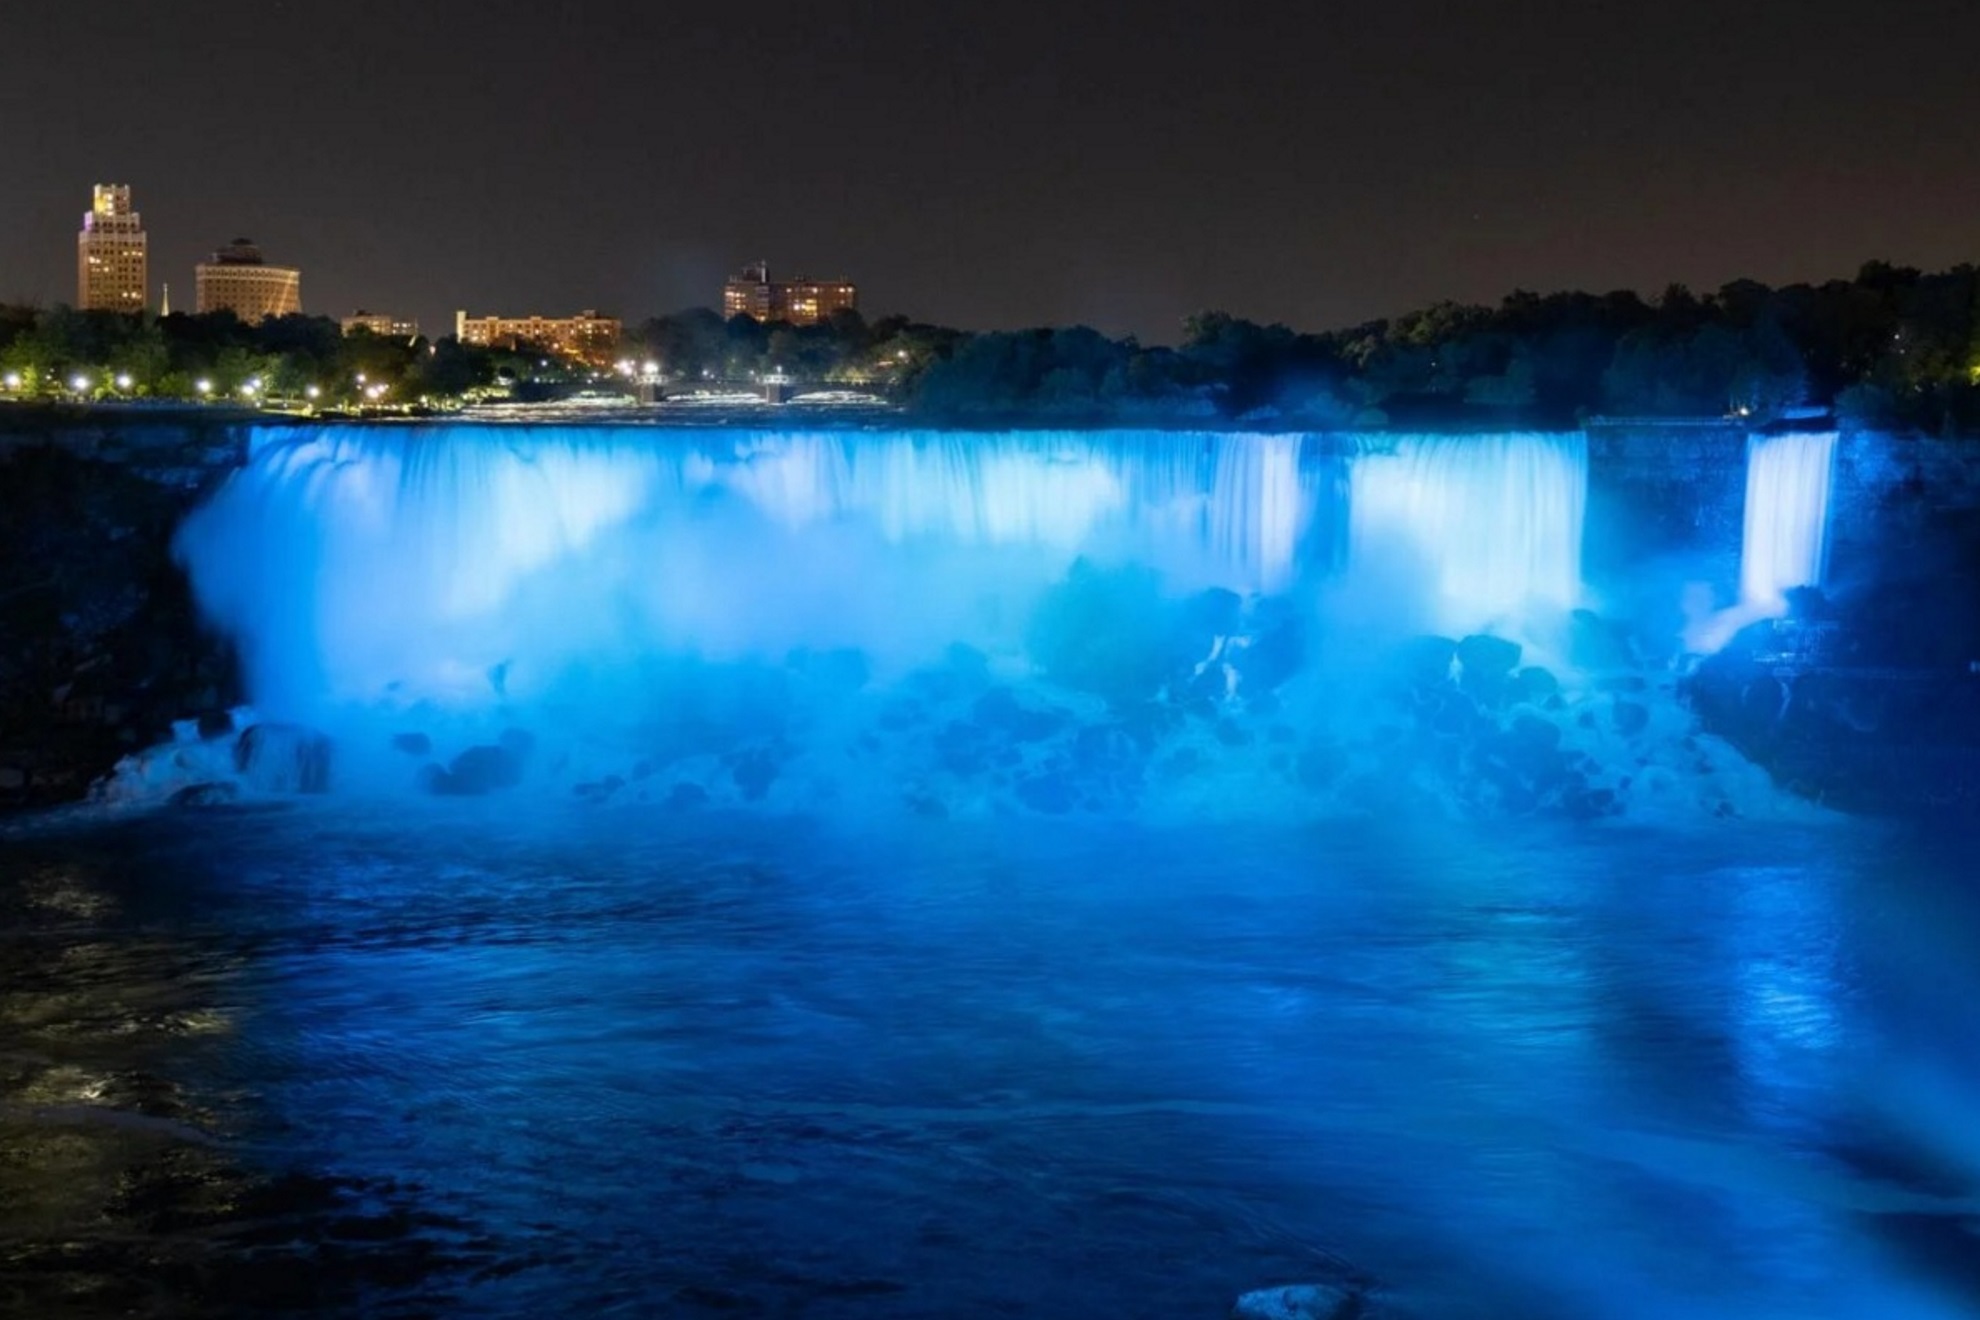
[[180, 425, 1586, 740]]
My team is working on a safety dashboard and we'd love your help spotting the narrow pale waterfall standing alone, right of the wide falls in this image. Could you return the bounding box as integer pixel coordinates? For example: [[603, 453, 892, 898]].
[[1738, 431, 1835, 613]]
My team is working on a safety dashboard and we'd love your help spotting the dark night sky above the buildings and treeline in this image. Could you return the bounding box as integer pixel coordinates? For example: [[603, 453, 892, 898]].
[[0, 0, 1980, 340]]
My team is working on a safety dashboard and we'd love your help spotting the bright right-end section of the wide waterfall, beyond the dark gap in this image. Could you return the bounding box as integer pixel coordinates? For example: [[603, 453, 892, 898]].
[[1348, 431, 1588, 633]]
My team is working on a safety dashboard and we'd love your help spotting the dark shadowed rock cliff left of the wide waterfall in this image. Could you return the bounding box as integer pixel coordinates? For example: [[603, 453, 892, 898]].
[[0, 429, 242, 809]]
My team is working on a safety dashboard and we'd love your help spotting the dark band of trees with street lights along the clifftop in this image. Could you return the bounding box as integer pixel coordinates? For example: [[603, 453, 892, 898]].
[[0, 261, 1980, 433]]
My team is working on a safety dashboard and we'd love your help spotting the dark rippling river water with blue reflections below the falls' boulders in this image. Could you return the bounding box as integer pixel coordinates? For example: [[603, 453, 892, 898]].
[[0, 801, 1980, 1320]]
